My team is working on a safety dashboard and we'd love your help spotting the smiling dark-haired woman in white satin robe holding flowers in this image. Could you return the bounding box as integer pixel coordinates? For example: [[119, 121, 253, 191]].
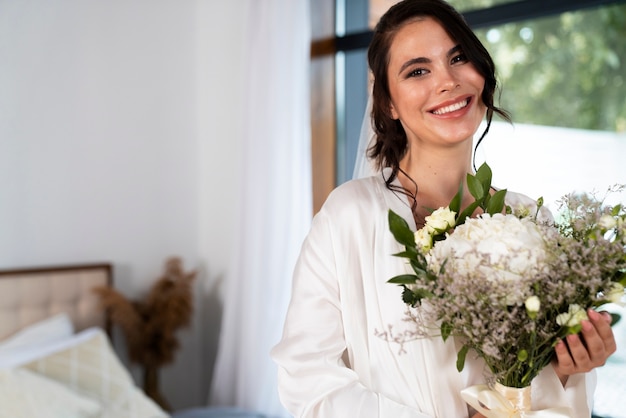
[[272, 0, 615, 418]]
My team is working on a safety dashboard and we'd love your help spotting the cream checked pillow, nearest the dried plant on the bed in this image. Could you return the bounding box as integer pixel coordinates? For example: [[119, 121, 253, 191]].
[[22, 328, 168, 418]]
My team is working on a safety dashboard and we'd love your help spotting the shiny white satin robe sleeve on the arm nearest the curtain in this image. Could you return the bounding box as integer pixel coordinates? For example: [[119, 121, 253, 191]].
[[271, 209, 427, 418]]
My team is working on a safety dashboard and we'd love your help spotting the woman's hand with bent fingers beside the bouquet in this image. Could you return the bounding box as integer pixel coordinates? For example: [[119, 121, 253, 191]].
[[552, 309, 617, 386]]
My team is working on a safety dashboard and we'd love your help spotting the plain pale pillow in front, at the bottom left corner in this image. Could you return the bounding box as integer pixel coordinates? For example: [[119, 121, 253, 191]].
[[0, 369, 101, 418]]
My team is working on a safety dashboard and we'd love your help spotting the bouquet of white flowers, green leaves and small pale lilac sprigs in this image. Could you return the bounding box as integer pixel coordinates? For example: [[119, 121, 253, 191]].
[[389, 164, 626, 416]]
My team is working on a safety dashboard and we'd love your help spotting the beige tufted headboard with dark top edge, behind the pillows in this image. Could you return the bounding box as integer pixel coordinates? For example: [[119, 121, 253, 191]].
[[0, 263, 113, 339]]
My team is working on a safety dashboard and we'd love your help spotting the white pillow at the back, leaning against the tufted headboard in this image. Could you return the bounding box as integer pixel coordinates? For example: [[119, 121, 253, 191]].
[[0, 313, 74, 357]]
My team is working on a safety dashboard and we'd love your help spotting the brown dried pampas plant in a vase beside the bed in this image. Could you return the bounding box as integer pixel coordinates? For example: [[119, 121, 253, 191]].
[[94, 257, 196, 411]]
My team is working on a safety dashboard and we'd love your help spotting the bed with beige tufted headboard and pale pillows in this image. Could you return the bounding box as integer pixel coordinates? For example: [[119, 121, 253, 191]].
[[0, 263, 263, 418]]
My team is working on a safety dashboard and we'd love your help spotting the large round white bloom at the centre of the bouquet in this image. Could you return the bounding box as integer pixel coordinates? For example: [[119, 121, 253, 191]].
[[429, 214, 546, 305]]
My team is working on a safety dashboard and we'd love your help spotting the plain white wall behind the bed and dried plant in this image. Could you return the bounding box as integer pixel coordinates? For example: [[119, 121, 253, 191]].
[[0, 0, 244, 408]]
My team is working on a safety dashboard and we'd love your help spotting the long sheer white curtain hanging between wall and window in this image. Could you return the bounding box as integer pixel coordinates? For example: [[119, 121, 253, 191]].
[[209, 0, 312, 417]]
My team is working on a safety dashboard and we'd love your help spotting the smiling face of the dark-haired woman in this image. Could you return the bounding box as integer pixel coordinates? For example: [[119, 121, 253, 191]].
[[387, 18, 486, 151]]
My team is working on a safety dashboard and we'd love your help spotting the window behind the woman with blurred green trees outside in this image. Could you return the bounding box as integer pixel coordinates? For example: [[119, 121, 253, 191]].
[[313, 0, 626, 207]]
